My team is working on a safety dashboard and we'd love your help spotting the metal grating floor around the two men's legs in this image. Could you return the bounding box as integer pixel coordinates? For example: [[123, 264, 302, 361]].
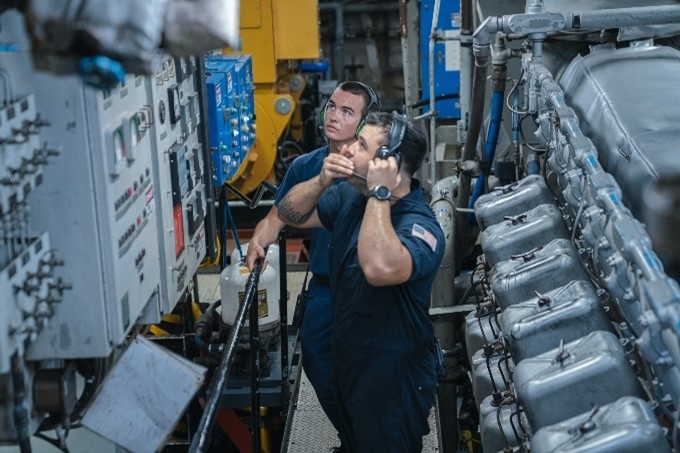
[[282, 372, 440, 453]]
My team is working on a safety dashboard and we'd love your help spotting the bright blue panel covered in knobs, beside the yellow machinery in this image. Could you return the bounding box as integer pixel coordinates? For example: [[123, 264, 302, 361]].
[[205, 55, 255, 187]]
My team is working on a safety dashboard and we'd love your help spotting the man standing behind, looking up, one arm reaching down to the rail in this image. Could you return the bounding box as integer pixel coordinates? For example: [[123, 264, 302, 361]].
[[246, 81, 380, 444]]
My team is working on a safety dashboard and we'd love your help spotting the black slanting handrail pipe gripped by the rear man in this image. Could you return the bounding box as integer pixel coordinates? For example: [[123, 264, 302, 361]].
[[189, 259, 262, 453]]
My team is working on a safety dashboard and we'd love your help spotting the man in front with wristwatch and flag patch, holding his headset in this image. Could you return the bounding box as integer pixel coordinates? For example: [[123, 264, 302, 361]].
[[279, 112, 444, 452]]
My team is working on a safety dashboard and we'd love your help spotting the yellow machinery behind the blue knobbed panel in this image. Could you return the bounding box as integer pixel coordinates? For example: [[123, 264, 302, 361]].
[[225, 0, 319, 193]]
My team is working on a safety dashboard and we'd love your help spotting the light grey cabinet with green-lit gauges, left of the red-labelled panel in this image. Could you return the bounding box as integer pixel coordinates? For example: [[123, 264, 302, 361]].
[[27, 71, 161, 360]]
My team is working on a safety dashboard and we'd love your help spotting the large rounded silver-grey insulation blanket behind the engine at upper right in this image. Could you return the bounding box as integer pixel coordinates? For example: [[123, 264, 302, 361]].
[[559, 46, 680, 217]]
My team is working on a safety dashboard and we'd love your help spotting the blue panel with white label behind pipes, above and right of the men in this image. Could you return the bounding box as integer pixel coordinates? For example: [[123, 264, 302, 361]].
[[419, 0, 460, 119]]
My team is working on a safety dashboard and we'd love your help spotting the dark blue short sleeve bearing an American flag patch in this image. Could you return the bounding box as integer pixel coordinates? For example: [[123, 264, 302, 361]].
[[397, 216, 444, 280]]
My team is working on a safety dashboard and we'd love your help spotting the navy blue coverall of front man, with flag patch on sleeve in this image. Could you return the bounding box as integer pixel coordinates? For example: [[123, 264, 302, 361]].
[[317, 180, 444, 453]]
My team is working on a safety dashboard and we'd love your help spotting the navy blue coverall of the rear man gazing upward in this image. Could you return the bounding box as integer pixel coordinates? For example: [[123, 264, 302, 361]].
[[275, 146, 339, 430]]
